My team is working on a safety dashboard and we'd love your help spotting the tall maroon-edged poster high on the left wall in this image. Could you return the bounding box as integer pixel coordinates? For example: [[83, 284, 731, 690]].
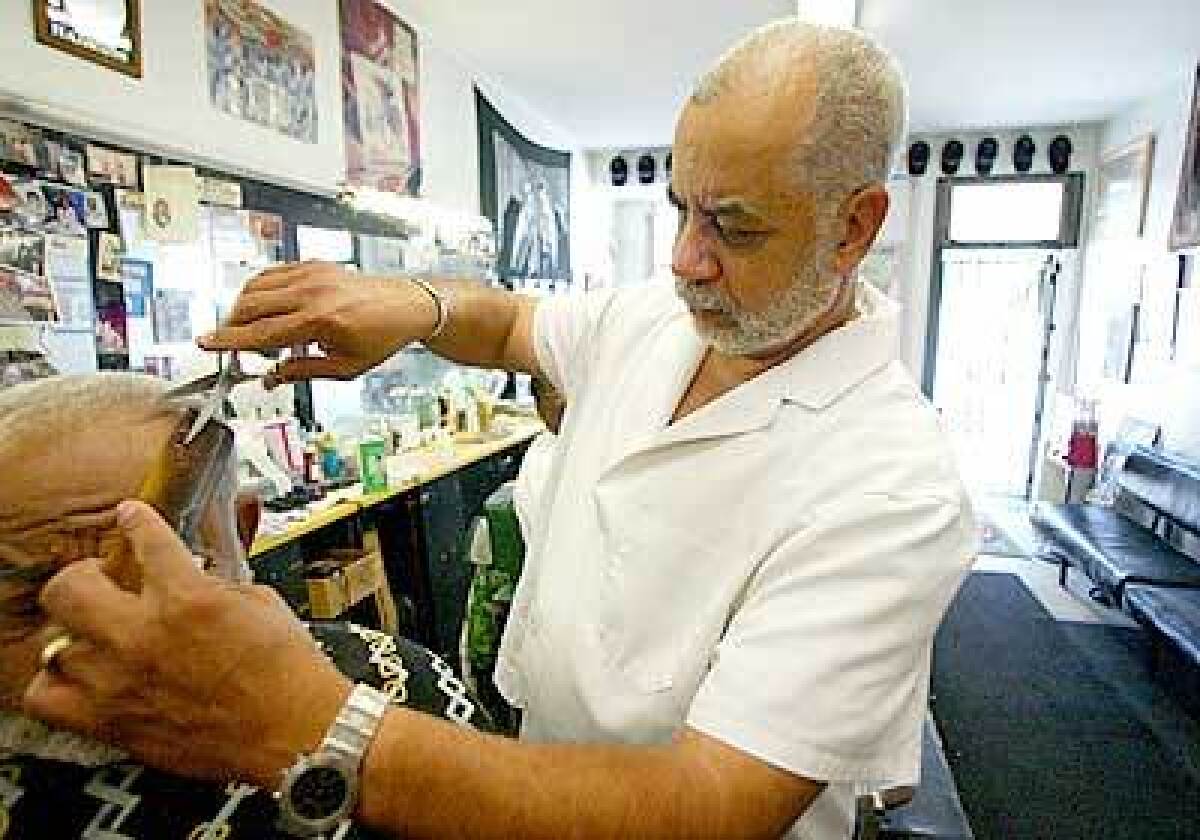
[[341, 0, 421, 196]]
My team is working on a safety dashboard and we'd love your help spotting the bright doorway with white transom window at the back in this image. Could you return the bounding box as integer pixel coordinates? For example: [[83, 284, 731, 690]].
[[924, 174, 1084, 499]]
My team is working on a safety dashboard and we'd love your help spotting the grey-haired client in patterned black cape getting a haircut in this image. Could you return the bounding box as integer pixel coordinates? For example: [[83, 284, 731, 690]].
[[0, 373, 486, 840]]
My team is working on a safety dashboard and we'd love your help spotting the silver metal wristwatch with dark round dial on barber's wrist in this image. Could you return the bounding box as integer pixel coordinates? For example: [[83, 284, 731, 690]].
[[276, 683, 389, 838]]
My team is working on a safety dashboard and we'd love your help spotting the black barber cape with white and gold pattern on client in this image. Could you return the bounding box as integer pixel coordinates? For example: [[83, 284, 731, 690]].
[[0, 623, 492, 840]]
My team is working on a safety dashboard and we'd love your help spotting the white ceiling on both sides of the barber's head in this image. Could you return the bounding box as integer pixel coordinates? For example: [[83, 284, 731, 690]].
[[422, 0, 1200, 148]]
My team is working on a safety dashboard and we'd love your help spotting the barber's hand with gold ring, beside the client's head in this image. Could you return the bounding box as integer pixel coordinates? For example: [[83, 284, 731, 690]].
[[25, 502, 350, 788]]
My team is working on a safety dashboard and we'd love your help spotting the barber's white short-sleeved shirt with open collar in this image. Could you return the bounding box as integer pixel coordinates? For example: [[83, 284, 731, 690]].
[[497, 278, 974, 840]]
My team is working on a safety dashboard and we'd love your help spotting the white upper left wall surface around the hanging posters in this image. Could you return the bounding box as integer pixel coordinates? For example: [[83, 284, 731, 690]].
[[0, 0, 576, 219]]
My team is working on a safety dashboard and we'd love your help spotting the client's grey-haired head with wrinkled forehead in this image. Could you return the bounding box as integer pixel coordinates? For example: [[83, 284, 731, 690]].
[[0, 373, 245, 757]]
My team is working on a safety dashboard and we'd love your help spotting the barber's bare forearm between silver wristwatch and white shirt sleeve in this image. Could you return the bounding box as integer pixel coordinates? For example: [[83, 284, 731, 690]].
[[358, 710, 820, 840]]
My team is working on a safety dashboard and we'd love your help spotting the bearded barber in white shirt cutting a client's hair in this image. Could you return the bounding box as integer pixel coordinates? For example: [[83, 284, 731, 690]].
[[26, 20, 973, 840]]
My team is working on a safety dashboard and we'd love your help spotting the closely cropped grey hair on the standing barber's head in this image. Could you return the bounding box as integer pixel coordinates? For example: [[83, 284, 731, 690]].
[[691, 18, 907, 206]]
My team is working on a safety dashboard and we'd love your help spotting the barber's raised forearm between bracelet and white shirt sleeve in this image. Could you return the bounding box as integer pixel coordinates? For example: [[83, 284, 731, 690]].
[[419, 280, 536, 373]]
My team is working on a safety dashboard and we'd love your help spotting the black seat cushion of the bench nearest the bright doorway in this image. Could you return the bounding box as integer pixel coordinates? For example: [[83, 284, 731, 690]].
[[1030, 502, 1200, 605]]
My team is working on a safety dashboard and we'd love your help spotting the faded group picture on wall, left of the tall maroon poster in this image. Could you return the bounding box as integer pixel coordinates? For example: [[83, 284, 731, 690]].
[[204, 0, 317, 143]]
